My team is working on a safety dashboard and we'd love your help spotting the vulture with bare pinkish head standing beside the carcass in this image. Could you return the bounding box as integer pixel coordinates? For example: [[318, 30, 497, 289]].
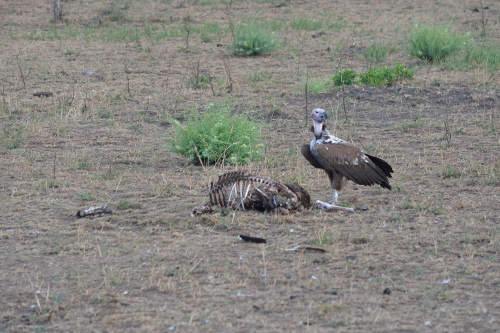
[[300, 109, 394, 211]]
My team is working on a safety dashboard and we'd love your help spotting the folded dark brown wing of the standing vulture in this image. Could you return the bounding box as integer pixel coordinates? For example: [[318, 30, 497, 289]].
[[316, 142, 392, 189]]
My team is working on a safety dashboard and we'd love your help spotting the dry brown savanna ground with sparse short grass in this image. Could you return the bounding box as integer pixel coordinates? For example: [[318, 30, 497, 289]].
[[0, 0, 500, 332]]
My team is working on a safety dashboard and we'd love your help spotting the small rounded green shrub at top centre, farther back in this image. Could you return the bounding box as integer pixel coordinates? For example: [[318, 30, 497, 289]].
[[234, 24, 278, 56]]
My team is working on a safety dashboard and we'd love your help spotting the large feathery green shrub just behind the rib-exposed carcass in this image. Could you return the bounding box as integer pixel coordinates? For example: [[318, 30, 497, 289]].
[[170, 100, 263, 164]]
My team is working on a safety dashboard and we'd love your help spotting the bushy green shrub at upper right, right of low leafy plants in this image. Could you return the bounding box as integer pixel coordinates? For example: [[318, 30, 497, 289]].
[[409, 25, 469, 63]]
